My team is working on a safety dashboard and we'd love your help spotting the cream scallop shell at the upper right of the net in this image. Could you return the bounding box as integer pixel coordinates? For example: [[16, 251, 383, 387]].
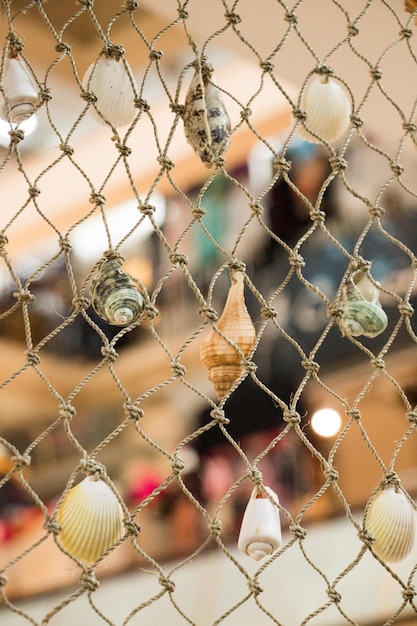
[[297, 75, 351, 143]]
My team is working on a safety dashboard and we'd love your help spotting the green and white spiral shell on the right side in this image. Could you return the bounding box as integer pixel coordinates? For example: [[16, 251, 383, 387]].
[[340, 270, 388, 337]]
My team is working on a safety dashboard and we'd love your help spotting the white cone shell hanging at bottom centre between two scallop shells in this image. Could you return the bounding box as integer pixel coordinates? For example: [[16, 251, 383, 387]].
[[237, 487, 282, 561]]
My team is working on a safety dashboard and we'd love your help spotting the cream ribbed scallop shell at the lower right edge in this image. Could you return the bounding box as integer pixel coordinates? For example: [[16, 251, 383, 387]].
[[364, 487, 415, 563]]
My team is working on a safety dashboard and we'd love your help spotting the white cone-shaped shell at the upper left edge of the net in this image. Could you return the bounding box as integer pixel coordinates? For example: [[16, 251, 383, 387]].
[[0, 56, 42, 124]]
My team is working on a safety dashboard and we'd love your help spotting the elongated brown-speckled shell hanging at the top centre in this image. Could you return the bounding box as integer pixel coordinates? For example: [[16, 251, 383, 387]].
[[184, 69, 230, 167]]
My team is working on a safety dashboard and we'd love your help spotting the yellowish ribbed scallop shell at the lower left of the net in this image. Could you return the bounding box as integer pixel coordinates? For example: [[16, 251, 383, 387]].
[[56, 476, 123, 563]]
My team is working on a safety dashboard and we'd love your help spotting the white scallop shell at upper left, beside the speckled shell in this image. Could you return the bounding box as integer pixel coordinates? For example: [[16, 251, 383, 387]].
[[82, 57, 137, 128]]
